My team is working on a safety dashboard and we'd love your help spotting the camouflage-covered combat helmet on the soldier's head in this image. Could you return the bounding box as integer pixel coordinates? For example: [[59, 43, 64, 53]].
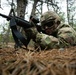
[[40, 11, 61, 27]]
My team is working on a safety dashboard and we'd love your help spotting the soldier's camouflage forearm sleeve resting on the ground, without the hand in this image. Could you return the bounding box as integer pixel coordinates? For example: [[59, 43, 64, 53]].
[[35, 33, 59, 49]]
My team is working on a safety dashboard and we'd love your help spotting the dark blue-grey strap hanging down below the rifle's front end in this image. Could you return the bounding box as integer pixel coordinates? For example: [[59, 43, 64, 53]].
[[10, 17, 28, 47]]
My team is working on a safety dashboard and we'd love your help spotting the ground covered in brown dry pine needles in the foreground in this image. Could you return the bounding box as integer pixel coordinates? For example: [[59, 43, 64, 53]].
[[0, 46, 76, 75]]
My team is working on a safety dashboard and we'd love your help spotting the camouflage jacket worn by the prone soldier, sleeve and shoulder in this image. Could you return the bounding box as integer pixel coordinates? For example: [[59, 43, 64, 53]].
[[27, 24, 76, 49]]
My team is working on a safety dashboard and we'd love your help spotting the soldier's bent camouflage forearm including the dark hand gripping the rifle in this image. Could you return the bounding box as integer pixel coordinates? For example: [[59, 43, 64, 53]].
[[26, 27, 59, 49]]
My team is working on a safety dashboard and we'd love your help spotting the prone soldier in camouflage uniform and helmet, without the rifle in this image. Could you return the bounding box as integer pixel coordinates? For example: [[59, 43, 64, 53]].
[[25, 11, 76, 49]]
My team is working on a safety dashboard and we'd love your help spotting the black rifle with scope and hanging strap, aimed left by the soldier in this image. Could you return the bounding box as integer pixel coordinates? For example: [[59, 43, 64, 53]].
[[0, 13, 42, 47]]
